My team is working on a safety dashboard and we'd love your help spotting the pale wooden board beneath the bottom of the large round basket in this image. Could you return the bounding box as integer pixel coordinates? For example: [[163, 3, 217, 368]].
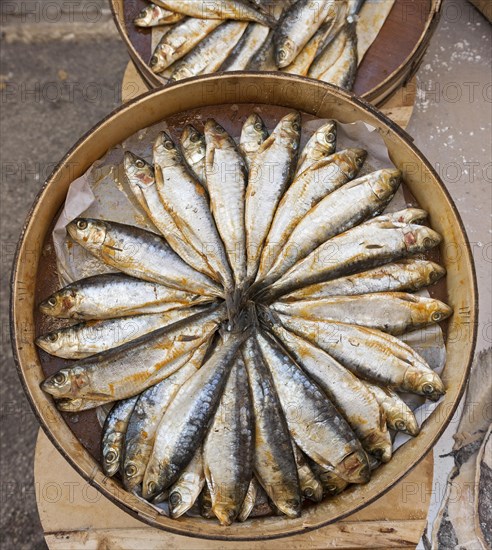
[[34, 430, 434, 550]]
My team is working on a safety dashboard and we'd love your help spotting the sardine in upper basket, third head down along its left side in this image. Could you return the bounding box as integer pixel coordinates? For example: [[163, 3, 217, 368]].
[[171, 21, 248, 82]]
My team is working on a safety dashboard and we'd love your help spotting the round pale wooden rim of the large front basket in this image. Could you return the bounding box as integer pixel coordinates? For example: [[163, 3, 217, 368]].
[[11, 73, 477, 541]]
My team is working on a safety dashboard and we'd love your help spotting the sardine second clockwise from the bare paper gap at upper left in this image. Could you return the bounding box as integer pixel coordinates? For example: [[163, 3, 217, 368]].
[[154, 132, 233, 292]]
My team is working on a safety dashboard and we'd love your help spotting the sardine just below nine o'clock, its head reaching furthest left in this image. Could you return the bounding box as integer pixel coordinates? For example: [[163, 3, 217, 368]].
[[36, 306, 211, 359]]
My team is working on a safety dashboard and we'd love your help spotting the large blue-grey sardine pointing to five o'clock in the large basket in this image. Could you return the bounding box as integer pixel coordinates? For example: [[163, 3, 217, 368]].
[[256, 332, 369, 483]]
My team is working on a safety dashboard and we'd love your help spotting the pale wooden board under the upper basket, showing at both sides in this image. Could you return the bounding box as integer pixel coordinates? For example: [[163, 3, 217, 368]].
[[121, 61, 417, 128]]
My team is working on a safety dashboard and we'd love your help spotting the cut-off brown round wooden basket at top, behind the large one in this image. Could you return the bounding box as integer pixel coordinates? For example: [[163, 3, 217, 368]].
[[110, 0, 442, 105]]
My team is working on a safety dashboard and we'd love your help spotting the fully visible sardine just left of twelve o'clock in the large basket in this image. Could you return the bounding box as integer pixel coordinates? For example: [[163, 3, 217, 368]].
[[205, 119, 248, 288]]
